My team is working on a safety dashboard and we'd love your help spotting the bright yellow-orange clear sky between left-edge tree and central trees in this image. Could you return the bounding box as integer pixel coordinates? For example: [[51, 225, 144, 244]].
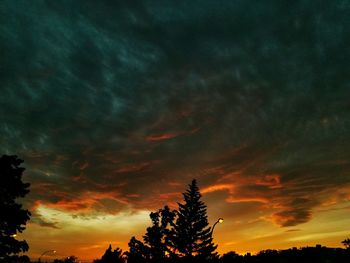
[[21, 204, 150, 262]]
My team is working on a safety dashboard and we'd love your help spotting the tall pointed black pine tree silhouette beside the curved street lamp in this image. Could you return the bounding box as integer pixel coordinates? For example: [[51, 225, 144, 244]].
[[174, 180, 217, 259]]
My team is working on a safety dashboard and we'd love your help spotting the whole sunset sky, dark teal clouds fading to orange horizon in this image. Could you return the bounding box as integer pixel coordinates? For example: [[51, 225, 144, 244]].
[[0, 0, 350, 259]]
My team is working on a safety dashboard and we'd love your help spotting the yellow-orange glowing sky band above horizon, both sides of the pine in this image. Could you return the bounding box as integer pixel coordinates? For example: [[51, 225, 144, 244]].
[[18, 188, 349, 260]]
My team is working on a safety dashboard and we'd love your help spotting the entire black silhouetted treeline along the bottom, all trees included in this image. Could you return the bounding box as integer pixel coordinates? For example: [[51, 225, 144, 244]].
[[0, 155, 350, 263]]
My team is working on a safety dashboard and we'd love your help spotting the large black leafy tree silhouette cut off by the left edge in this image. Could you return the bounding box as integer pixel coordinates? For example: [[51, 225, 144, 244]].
[[0, 155, 30, 262]]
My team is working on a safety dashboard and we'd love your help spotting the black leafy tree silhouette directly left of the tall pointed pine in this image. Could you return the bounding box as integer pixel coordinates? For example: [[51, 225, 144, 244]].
[[143, 206, 175, 262]]
